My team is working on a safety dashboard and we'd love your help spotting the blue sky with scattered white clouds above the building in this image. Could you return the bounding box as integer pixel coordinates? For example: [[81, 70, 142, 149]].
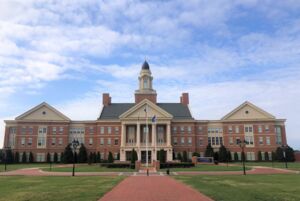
[[0, 0, 300, 149]]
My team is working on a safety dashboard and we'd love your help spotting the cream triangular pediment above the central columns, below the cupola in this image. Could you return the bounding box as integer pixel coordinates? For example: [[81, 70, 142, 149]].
[[120, 99, 173, 119]]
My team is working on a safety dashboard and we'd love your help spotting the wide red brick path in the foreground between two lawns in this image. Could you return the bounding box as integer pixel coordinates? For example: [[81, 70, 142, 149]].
[[99, 176, 212, 201]]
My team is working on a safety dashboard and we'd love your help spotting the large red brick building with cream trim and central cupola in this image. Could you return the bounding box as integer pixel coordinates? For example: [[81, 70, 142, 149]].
[[4, 61, 287, 162]]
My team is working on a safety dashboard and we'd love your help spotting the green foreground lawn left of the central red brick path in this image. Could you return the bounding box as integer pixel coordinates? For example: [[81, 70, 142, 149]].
[[0, 176, 124, 201]]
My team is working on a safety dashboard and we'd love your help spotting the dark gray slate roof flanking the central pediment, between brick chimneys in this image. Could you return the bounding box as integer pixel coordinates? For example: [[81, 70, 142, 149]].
[[98, 103, 193, 120]]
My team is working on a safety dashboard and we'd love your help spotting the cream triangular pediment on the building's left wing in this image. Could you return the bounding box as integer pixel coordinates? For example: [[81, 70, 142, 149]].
[[16, 102, 70, 121]]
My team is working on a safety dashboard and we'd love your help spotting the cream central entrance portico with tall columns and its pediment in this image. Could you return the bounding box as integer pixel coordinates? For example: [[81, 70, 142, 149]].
[[120, 99, 173, 162]]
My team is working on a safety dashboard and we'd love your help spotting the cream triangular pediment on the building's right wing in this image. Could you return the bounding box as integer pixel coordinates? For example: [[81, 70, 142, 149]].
[[222, 101, 275, 120]]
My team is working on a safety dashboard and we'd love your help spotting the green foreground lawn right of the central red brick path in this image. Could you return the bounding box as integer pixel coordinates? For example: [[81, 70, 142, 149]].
[[175, 175, 300, 201]]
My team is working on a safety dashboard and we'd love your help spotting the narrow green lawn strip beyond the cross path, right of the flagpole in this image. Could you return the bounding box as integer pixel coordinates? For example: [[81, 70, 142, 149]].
[[160, 164, 251, 172]]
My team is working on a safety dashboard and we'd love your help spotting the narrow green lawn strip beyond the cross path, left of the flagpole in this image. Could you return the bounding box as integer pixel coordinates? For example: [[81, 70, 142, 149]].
[[43, 164, 135, 172]]
